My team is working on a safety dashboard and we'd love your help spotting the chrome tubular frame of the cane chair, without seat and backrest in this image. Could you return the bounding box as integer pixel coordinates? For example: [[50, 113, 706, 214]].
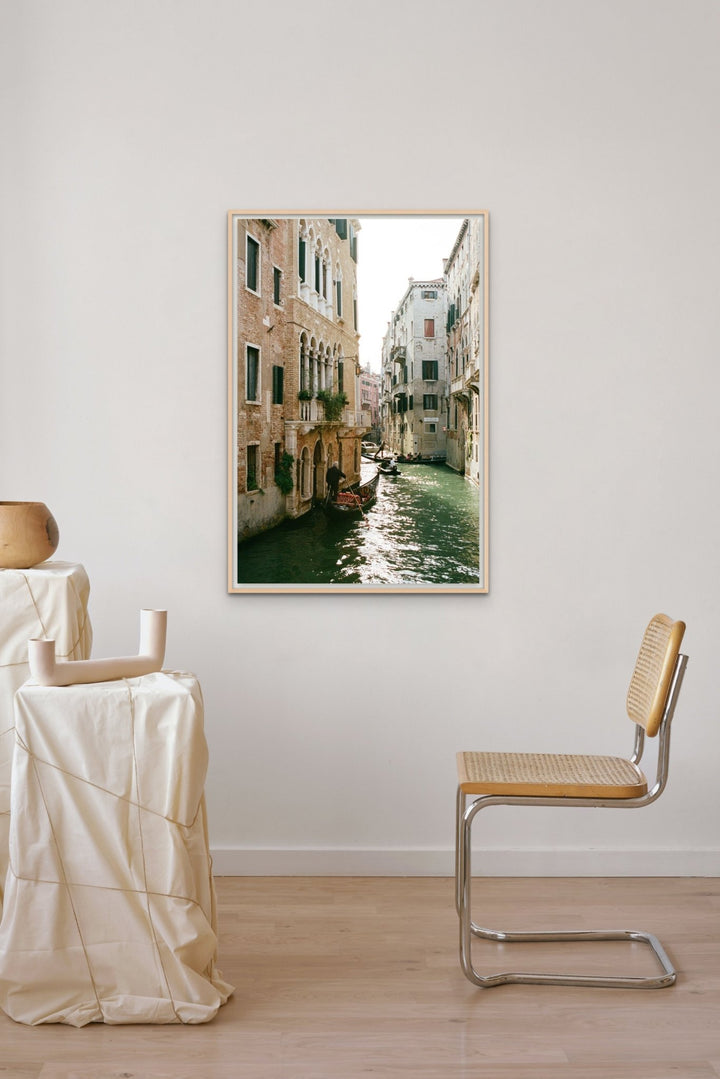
[[456, 654, 688, 989]]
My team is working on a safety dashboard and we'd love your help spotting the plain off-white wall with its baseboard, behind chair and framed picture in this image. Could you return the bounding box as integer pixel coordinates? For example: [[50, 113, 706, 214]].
[[0, 0, 720, 874]]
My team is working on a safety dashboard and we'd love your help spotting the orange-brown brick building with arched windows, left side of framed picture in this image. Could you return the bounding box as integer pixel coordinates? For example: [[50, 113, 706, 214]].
[[231, 217, 369, 540]]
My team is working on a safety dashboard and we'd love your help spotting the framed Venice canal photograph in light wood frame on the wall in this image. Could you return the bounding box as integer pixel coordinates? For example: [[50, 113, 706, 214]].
[[228, 210, 489, 593]]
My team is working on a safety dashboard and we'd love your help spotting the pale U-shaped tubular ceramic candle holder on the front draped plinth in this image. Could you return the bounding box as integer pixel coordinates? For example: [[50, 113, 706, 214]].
[[28, 611, 167, 685]]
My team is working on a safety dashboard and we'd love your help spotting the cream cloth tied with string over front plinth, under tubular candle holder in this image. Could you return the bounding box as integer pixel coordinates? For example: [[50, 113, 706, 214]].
[[0, 671, 232, 1026]]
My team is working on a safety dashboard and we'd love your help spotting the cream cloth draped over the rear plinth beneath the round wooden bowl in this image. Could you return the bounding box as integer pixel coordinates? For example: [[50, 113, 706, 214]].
[[0, 562, 93, 912]]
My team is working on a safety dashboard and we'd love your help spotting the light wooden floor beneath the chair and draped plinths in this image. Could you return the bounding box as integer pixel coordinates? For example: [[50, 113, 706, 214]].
[[0, 877, 720, 1079]]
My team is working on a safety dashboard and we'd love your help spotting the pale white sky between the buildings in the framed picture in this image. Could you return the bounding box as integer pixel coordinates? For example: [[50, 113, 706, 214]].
[[357, 215, 463, 371]]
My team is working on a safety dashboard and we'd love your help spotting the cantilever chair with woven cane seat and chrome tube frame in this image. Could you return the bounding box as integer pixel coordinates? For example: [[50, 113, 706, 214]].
[[456, 614, 688, 988]]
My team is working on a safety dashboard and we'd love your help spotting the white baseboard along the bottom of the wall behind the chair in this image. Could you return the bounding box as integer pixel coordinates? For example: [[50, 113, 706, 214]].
[[212, 847, 720, 877]]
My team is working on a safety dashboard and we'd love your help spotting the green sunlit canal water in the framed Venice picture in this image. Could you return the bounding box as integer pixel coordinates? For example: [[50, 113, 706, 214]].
[[237, 463, 479, 586]]
